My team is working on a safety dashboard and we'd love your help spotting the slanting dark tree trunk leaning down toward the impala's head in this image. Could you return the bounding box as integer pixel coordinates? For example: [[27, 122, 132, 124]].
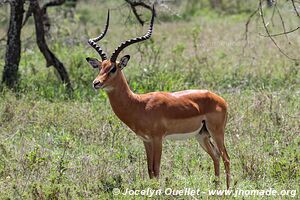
[[30, 0, 73, 92]]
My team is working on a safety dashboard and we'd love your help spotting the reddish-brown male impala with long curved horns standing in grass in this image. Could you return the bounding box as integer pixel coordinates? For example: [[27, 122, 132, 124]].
[[86, 8, 230, 188]]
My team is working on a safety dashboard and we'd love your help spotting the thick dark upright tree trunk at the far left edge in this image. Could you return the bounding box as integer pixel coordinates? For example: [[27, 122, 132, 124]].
[[2, 0, 24, 88]]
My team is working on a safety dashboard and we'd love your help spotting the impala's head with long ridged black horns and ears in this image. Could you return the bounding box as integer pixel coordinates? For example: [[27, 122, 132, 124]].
[[86, 7, 154, 89]]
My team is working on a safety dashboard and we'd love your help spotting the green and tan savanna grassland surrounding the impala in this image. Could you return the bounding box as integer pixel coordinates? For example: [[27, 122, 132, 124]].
[[0, 0, 300, 199]]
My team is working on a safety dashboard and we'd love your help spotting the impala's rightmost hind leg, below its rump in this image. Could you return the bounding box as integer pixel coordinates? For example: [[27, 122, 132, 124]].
[[207, 120, 230, 189]]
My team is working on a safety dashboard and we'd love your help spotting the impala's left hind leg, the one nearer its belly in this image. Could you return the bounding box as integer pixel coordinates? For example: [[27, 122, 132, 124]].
[[196, 124, 220, 187]]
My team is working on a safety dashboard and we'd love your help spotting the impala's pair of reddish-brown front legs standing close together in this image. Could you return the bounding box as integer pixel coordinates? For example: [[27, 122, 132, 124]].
[[144, 138, 162, 178]]
